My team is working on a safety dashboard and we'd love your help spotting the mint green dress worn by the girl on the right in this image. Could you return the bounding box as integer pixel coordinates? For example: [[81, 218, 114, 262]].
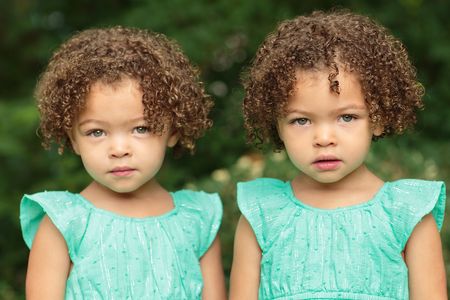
[[238, 178, 445, 300]]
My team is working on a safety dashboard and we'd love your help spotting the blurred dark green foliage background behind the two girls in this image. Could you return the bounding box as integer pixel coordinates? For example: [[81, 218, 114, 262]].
[[0, 0, 450, 300]]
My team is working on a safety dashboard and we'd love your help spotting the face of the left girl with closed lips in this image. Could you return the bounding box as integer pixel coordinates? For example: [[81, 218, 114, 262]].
[[70, 79, 177, 193]]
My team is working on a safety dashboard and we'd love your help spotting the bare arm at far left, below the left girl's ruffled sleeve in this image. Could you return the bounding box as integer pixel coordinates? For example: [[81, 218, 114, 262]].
[[26, 216, 70, 300]]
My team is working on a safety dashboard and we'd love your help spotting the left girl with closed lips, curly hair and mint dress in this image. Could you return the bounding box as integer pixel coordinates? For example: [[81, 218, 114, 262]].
[[20, 27, 225, 299]]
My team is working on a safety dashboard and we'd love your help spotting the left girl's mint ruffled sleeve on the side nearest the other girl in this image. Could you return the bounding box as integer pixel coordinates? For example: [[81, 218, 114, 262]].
[[177, 190, 223, 258]]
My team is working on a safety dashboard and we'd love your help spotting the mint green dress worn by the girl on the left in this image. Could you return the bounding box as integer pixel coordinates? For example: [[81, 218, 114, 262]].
[[20, 190, 222, 300]]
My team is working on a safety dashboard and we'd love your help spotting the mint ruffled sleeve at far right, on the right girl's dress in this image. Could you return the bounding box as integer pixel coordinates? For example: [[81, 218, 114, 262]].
[[389, 179, 446, 248]]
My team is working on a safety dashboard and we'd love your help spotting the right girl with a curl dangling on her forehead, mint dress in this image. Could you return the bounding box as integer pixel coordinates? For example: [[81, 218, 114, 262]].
[[230, 11, 447, 299]]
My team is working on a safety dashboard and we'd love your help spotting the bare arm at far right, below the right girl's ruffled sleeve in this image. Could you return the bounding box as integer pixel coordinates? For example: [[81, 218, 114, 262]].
[[405, 214, 447, 300]]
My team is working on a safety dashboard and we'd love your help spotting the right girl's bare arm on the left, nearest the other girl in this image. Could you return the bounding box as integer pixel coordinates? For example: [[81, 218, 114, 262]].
[[230, 216, 261, 300]]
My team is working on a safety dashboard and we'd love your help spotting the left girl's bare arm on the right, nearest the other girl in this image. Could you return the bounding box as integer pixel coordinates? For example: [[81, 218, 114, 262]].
[[200, 237, 226, 300]]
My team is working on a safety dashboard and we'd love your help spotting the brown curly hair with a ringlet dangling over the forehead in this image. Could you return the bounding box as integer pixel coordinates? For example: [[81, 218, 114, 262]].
[[243, 10, 424, 150]]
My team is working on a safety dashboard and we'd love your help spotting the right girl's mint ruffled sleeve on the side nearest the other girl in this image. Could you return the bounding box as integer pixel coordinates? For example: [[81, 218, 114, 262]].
[[237, 178, 299, 252]]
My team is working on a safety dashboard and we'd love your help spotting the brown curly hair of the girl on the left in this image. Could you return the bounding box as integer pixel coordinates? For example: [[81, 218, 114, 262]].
[[35, 26, 213, 153]]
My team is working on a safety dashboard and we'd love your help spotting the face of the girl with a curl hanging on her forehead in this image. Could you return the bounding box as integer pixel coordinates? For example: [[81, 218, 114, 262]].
[[278, 70, 381, 183]]
